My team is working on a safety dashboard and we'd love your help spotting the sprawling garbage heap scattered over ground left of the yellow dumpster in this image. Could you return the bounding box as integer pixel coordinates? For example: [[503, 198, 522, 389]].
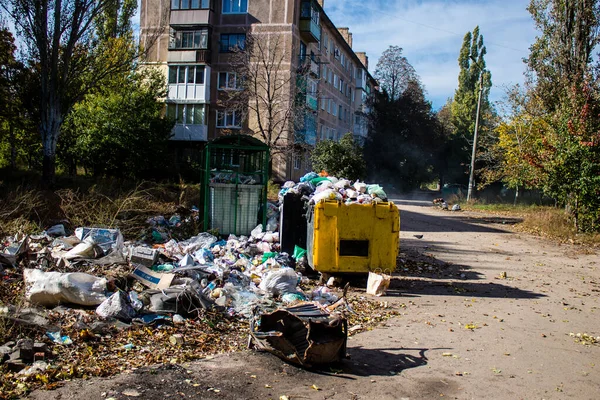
[[0, 185, 404, 394]]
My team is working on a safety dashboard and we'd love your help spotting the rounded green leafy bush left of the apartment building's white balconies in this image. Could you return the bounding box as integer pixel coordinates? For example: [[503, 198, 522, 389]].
[[61, 69, 173, 178]]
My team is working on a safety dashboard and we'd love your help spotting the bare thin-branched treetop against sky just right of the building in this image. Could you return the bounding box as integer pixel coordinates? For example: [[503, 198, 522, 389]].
[[375, 46, 418, 101]]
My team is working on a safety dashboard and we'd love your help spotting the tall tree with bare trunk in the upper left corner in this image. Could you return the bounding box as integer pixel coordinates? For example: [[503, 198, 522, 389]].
[[2, 0, 165, 185]]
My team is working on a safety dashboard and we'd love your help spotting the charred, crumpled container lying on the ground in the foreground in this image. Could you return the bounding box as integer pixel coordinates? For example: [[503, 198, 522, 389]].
[[249, 303, 348, 368]]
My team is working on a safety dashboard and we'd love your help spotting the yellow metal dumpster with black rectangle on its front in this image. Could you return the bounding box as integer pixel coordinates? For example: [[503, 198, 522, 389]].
[[307, 201, 400, 274]]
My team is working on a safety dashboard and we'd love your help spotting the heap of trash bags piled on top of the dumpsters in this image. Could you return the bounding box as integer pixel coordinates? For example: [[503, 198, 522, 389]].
[[279, 172, 387, 204]]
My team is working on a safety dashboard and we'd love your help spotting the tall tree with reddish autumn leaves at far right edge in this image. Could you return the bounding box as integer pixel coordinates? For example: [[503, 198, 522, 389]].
[[526, 0, 600, 231]]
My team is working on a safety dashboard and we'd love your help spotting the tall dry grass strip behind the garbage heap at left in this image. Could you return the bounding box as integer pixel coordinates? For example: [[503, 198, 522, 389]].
[[0, 182, 201, 239]]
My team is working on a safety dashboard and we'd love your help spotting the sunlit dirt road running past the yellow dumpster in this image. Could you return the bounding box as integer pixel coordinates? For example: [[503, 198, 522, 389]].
[[31, 200, 600, 399]]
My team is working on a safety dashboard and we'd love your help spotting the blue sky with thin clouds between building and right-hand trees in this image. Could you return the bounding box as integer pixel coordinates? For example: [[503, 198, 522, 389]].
[[325, 0, 537, 109]]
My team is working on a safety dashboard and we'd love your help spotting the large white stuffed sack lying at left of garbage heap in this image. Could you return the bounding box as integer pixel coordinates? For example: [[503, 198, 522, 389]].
[[23, 269, 107, 307]]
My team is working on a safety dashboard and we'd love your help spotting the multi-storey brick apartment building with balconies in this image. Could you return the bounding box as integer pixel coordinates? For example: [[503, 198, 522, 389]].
[[140, 0, 376, 180]]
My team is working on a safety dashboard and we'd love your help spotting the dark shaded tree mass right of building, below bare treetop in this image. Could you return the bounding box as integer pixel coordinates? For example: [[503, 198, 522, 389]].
[[365, 82, 444, 190]]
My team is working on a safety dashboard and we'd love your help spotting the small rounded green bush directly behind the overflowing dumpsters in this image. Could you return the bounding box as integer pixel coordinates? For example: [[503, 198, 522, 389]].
[[311, 133, 366, 180]]
